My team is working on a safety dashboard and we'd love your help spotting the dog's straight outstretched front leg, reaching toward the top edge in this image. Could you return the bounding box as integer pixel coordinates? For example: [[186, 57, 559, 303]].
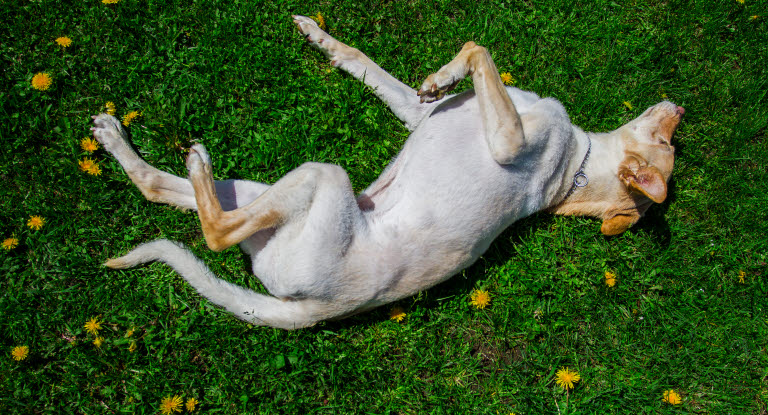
[[293, 16, 428, 130]]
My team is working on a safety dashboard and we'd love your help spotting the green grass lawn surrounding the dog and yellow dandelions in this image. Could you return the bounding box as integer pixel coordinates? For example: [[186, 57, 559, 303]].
[[0, 0, 768, 414]]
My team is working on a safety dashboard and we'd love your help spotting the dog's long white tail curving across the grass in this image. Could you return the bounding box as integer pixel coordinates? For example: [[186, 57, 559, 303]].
[[104, 239, 330, 330]]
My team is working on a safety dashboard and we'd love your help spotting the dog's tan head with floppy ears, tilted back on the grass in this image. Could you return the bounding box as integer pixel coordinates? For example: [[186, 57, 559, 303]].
[[553, 101, 685, 235]]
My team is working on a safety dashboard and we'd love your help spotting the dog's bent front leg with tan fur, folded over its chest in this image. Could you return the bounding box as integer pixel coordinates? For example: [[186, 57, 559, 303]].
[[418, 42, 525, 164]]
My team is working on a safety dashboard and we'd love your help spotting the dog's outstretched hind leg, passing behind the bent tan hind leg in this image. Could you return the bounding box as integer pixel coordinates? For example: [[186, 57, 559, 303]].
[[91, 114, 269, 210]]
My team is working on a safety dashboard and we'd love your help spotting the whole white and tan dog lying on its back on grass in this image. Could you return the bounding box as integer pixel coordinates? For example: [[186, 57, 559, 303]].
[[92, 16, 685, 329]]
